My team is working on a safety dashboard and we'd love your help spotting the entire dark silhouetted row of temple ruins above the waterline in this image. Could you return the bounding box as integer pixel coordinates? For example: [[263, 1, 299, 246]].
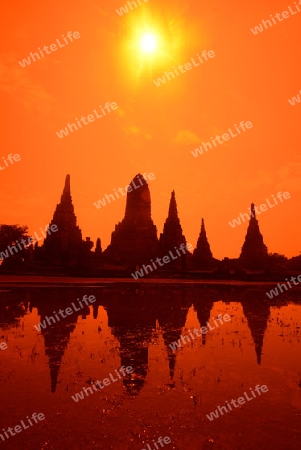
[[3, 174, 290, 278]]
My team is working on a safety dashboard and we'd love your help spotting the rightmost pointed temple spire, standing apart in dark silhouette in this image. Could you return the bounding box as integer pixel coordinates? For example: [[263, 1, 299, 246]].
[[239, 203, 268, 270]]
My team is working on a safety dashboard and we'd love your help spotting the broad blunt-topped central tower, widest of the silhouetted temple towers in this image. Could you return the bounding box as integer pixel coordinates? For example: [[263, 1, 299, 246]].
[[104, 174, 158, 266]]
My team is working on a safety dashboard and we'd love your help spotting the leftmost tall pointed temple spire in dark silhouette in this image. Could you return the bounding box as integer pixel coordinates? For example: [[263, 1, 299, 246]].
[[41, 175, 83, 266]]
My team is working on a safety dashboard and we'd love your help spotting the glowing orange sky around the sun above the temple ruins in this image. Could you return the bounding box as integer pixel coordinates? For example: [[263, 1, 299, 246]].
[[0, 0, 301, 258]]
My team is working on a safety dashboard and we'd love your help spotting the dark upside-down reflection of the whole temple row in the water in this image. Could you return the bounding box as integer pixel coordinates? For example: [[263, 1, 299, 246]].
[[0, 285, 300, 395]]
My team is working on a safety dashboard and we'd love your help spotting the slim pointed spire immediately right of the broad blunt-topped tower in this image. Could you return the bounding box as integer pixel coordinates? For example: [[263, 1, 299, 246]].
[[159, 191, 186, 269]]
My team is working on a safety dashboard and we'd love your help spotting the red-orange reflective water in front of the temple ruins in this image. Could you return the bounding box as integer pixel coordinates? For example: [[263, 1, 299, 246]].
[[0, 283, 301, 450]]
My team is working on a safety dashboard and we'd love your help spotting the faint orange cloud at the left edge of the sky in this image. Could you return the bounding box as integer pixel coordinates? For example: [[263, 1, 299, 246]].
[[0, 53, 54, 113]]
